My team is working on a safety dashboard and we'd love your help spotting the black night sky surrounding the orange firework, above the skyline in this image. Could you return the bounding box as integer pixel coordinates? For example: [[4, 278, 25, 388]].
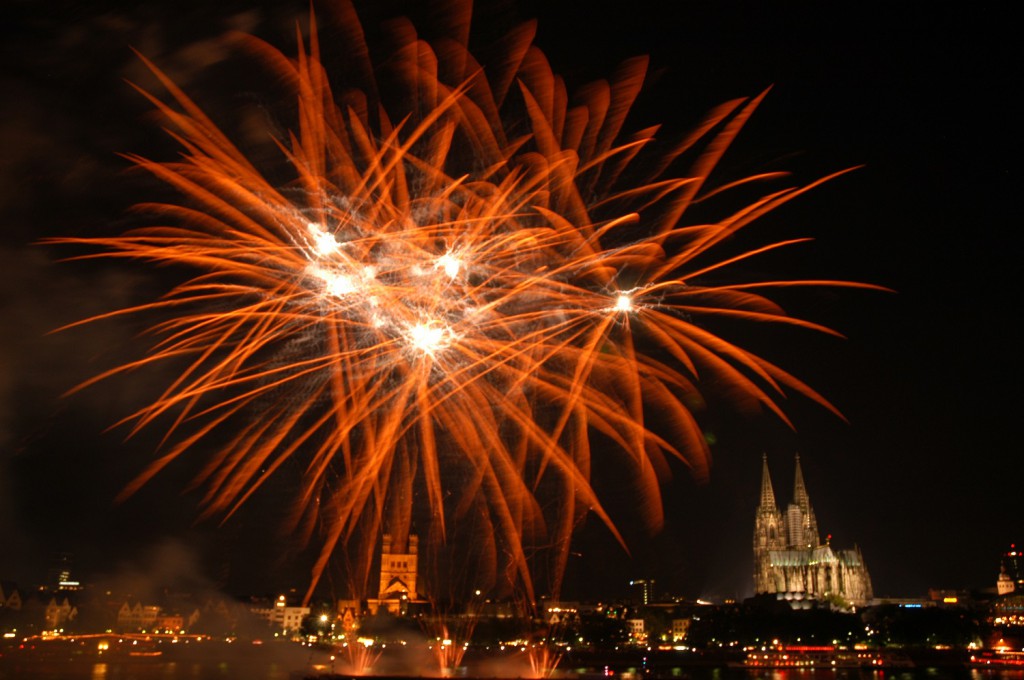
[[0, 0, 1024, 597]]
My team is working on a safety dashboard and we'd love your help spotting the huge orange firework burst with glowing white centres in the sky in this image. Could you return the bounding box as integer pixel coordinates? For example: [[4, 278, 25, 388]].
[[49, 2, 880, 606]]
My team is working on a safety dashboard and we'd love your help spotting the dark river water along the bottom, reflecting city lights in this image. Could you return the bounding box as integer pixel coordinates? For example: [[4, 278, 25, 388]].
[[0, 636, 1024, 680]]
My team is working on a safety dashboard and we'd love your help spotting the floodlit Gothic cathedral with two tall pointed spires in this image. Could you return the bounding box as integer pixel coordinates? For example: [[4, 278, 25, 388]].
[[754, 456, 872, 606]]
